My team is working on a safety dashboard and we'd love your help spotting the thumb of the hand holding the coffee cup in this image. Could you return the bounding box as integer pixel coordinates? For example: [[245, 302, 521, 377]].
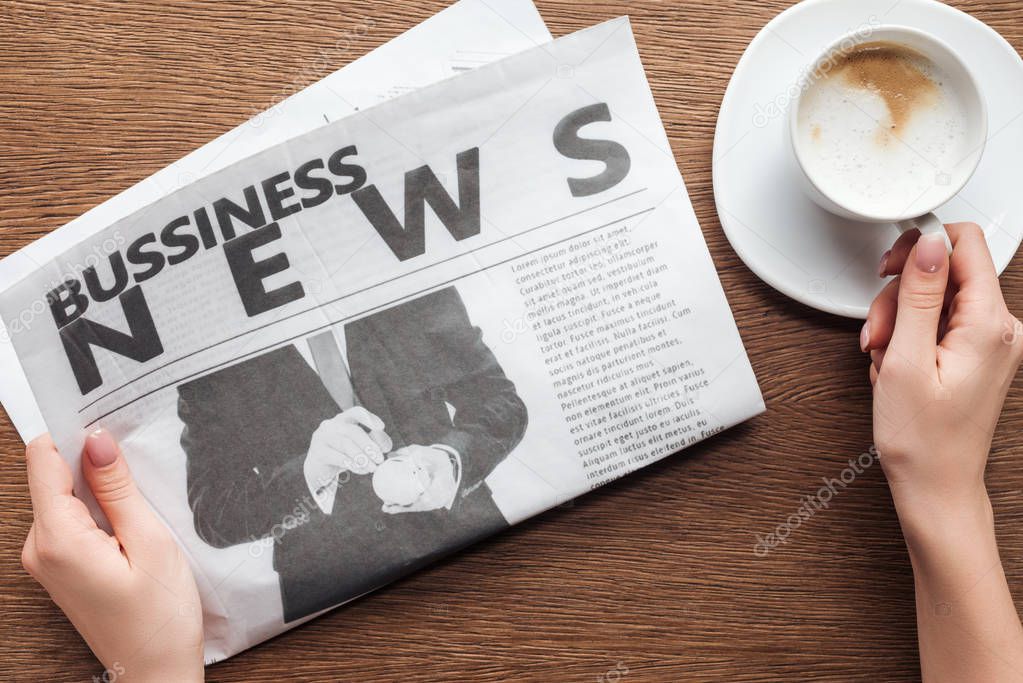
[[889, 232, 948, 368]]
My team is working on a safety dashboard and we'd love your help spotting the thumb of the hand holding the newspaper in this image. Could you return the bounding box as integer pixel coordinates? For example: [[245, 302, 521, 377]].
[[82, 429, 165, 559]]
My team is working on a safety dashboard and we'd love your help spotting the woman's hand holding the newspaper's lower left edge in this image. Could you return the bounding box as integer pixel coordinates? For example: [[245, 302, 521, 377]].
[[21, 431, 204, 681]]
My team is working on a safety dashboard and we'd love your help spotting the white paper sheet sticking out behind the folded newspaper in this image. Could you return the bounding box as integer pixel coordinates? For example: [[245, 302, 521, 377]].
[[0, 0, 551, 442]]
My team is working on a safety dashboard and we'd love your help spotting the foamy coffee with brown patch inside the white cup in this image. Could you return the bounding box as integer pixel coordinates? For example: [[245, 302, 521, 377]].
[[796, 42, 971, 216]]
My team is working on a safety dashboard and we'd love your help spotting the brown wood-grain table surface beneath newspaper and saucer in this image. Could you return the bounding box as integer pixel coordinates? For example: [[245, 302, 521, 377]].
[[0, 0, 1023, 683]]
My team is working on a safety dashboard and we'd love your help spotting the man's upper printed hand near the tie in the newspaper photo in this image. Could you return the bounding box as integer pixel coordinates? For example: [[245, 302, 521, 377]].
[[304, 406, 393, 496]]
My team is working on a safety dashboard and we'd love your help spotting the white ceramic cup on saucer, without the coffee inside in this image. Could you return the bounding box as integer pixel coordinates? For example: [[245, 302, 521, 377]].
[[785, 26, 987, 248]]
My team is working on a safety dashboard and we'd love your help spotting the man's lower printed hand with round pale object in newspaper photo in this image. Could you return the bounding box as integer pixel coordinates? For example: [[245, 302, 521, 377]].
[[373, 446, 459, 514]]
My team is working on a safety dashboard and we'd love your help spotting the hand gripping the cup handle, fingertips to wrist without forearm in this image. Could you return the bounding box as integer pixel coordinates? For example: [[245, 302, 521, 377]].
[[861, 223, 1023, 540]]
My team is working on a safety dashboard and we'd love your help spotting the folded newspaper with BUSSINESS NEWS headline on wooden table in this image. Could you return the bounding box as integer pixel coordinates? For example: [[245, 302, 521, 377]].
[[0, 5, 763, 662]]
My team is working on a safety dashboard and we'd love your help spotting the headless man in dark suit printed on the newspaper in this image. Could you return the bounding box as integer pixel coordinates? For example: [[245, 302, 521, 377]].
[[178, 287, 527, 622]]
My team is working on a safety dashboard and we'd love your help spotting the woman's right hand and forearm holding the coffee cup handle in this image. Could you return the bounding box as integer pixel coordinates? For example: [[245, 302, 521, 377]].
[[860, 223, 1023, 683]]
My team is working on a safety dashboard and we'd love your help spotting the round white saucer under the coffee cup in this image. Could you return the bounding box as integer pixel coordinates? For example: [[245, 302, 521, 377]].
[[714, 0, 1023, 318]]
